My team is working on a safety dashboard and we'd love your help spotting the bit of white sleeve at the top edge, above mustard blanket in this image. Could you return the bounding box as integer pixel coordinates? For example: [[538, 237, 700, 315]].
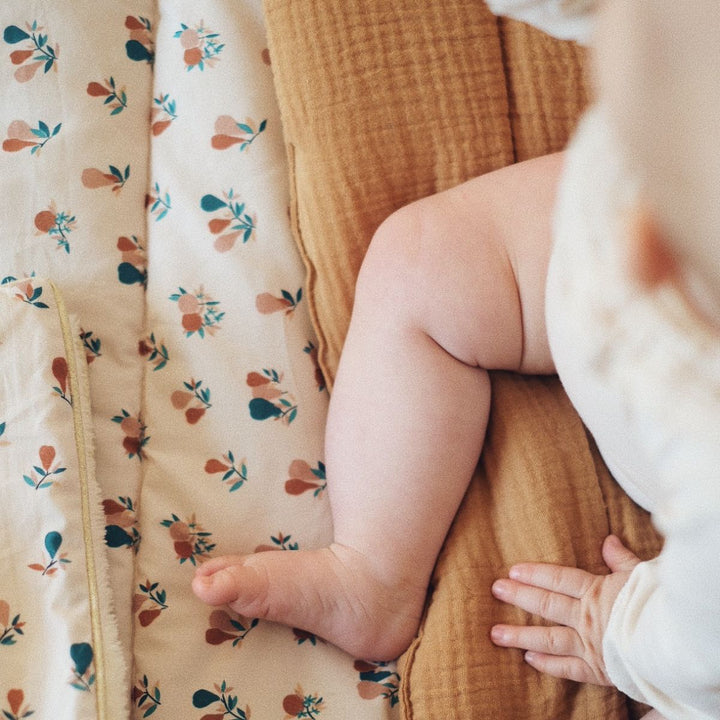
[[487, 0, 596, 45]]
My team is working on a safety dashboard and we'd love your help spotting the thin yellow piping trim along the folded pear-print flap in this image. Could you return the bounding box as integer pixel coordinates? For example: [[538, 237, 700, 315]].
[[50, 283, 109, 720]]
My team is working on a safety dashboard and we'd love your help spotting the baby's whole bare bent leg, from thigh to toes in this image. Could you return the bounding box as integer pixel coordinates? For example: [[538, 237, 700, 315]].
[[193, 156, 561, 660]]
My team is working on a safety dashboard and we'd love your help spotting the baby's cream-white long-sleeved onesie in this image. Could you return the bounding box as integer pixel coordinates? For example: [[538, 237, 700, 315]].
[[489, 0, 720, 720]]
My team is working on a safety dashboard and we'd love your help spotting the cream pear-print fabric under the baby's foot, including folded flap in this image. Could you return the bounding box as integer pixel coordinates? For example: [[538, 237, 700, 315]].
[[0, 0, 399, 720]]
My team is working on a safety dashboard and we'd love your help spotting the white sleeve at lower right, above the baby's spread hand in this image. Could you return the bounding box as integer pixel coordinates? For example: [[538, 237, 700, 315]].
[[603, 479, 720, 720]]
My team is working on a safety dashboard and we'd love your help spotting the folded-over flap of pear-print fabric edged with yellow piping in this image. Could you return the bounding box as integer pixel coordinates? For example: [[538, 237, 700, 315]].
[[0, 278, 128, 720]]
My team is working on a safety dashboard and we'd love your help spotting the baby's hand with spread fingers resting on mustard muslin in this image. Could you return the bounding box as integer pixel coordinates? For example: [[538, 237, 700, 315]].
[[490, 535, 640, 685]]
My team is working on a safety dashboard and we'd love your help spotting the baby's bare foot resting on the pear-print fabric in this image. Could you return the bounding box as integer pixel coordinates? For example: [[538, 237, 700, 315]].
[[192, 544, 426, 660]]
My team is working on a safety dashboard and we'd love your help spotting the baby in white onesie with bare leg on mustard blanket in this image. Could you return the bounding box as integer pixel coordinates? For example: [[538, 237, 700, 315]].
[[193, 0, 720, 720]]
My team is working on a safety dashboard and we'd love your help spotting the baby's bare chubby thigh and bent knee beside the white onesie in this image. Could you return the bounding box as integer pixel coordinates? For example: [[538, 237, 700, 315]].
[[358, 154, 562, 373]]
